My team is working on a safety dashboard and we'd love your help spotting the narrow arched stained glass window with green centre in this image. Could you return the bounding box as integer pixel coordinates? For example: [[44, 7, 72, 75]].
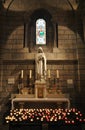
[[36, 19, 46, 45]]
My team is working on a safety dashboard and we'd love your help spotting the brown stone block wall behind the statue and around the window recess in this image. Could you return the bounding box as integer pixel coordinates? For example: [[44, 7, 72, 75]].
[[0, 0, 85, 130]]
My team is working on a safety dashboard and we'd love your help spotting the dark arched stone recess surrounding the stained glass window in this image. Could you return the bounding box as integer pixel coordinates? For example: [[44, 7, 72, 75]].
[[25, 9, 54, 52]]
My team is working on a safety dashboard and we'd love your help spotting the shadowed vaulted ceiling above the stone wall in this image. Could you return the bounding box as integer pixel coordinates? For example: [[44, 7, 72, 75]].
[[0, 0, 85, 11]]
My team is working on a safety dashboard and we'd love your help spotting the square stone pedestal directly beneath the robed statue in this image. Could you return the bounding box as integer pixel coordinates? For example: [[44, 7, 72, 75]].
[[35, 80, 46, 98]]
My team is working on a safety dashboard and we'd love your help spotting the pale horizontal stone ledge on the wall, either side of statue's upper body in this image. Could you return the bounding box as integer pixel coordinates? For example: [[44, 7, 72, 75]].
[[2, 53, 77, 61]]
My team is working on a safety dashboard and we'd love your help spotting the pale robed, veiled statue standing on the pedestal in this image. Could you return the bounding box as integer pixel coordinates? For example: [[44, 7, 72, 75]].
[[35, 47, 47, 80]]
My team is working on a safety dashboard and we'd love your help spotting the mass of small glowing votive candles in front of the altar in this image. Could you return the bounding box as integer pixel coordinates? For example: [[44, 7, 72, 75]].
[[5, 108, 85, 124]]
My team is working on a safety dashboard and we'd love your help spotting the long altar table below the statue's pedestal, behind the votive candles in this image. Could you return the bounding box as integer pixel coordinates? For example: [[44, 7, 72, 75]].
[[11, 98, 70, 110]]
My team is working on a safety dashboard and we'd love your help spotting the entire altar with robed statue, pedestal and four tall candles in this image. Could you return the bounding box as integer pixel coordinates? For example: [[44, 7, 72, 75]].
[[11, 47, 70, 109]]
